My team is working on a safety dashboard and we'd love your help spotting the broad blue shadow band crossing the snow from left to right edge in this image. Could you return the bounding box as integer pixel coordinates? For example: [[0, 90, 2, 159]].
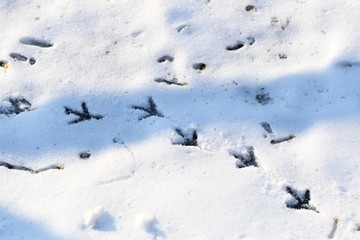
[[0, 58, 360, 164]]
